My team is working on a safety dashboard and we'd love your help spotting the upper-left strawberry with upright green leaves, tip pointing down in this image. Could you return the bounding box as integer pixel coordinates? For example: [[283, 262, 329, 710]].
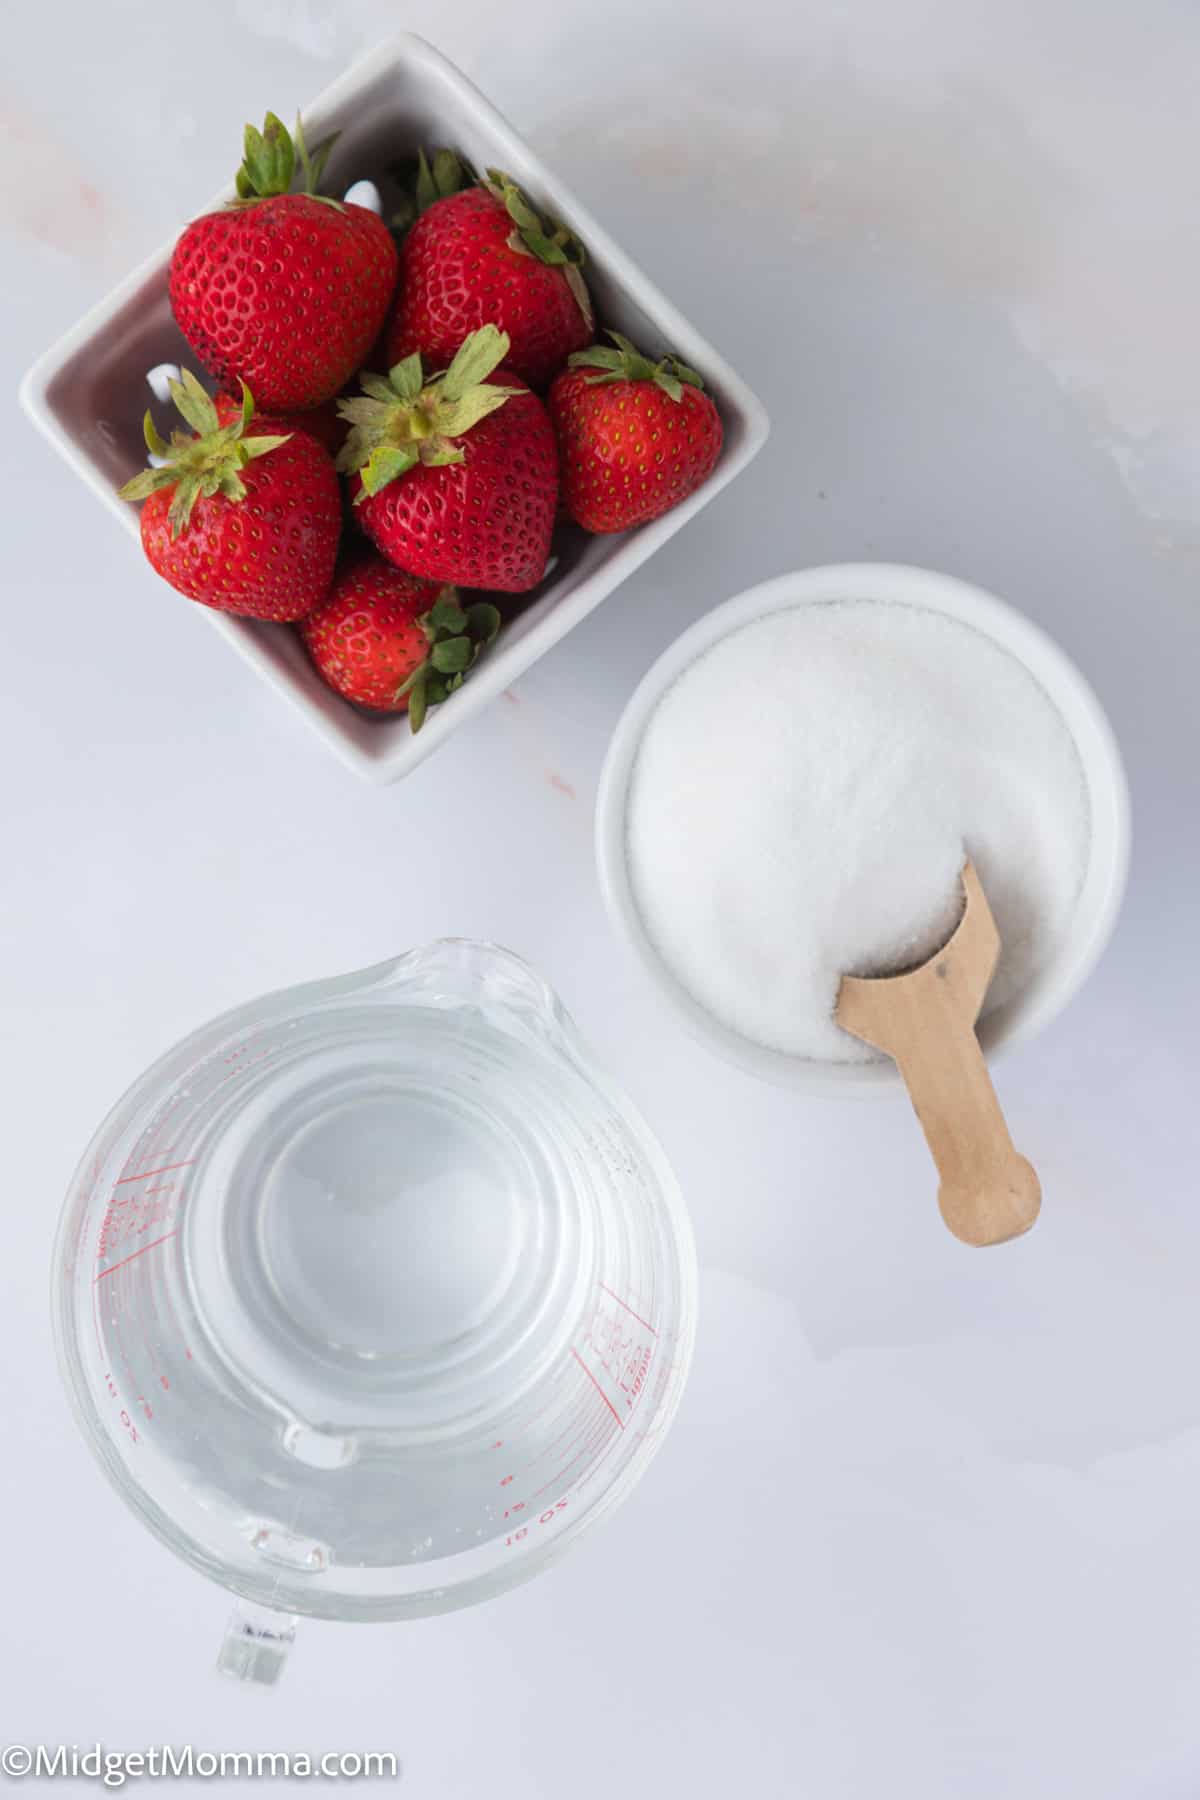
[[169, 113, 398, 410]]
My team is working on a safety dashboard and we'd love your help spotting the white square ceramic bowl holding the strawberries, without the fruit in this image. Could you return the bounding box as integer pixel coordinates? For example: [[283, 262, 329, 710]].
[[22, 36, 768, 781]]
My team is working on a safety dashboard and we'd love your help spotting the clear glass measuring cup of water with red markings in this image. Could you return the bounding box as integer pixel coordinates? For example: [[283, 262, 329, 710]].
[[54, 940, 694, 1679]]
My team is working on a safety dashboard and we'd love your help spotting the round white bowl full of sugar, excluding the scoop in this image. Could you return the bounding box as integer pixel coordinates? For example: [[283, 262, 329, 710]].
[[596, 563, 1130, 1093]]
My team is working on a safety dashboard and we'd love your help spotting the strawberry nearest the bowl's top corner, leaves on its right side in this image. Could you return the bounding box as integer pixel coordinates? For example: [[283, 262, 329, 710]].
[[387, 151, 592, 387]]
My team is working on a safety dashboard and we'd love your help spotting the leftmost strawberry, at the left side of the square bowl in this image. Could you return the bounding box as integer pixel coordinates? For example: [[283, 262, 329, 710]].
[[121, 369, 342, 619]]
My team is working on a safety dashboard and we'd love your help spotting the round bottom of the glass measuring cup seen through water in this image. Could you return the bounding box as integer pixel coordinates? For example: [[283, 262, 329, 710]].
[[193, 1006, 601, 1438]]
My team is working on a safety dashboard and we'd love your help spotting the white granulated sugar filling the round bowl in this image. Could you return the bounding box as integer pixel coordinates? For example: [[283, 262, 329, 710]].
[[628, 601, 1090, 1062]]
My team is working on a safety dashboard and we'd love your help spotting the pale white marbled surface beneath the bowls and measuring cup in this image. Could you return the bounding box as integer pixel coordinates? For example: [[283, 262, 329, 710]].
[[0, 0, 1200, 1800]]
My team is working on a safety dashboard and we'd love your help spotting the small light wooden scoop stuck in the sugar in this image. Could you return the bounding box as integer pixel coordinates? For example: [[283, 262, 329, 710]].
[[837, 862, 1042, 1244]]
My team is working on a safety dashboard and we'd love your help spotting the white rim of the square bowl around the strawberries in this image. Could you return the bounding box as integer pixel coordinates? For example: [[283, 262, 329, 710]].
[[18, 32, 770, 785]]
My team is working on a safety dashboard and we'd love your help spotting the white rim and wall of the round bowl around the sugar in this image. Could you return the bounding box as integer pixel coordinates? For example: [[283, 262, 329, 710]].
[[596, 563, 1130, 1093]]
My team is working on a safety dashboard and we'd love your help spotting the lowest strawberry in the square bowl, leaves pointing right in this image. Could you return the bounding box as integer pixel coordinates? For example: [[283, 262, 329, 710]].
[[300, 551, 500, 731]]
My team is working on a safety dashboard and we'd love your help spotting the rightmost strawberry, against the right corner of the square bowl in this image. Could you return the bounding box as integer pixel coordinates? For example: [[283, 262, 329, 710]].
[[547, 331, 721, 531]]
